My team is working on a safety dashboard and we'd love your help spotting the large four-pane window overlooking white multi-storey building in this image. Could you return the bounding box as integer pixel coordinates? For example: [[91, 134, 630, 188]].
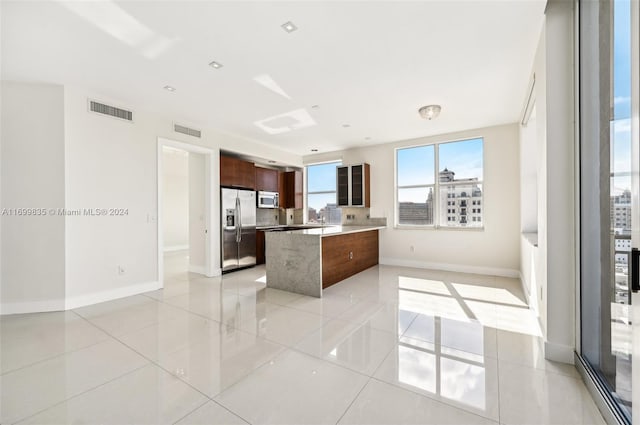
[[396, 138, 484, 227]]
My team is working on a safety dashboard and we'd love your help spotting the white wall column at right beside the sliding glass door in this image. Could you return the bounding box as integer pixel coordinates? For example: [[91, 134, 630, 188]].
[[521, 1, 577, 363]]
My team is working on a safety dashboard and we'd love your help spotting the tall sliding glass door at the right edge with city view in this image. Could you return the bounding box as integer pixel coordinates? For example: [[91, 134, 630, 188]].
[[579, 0, 640, 423]]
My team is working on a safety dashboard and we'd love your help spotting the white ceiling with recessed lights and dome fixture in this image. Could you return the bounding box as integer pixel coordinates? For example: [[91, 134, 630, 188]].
[[1, 0, 546, 155]]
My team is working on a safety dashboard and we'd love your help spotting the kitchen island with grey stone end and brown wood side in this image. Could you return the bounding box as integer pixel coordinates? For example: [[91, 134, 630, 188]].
[[265, 226, 385, 298]]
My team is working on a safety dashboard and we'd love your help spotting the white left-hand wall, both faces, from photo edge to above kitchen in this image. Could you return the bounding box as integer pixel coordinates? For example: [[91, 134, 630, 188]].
[[1, 82, 302, 313]]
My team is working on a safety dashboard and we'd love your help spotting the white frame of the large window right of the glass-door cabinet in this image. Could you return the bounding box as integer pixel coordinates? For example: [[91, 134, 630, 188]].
[[394, 136, 486, 231]]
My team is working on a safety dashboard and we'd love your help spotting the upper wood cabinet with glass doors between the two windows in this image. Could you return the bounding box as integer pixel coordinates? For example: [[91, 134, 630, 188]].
[[336, 164, 371, 208]]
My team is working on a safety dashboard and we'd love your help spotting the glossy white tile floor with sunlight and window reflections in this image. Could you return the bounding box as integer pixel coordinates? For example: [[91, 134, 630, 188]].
[[0, 253, 604, 424]]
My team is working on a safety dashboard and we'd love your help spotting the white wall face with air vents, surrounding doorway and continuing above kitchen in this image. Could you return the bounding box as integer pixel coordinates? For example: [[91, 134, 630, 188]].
[[65, 83, 302, 305]]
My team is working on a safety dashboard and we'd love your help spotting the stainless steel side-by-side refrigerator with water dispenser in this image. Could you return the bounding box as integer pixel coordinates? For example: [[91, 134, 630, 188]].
[[220, 188, 256, 273]]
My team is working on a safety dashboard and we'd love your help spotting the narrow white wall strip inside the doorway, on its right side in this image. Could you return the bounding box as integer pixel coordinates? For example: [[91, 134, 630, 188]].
[[188, 152, 207, 274]]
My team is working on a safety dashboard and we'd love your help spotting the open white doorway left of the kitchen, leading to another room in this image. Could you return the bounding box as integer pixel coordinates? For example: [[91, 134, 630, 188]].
[[158, 138, 219, 287]]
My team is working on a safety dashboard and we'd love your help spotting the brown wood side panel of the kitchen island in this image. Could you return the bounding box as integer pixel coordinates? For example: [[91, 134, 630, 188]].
[[322, 230, 378, 288]]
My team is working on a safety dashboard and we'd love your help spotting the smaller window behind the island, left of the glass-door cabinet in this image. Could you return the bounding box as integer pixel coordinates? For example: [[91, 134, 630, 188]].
[[307, 162, 342, 224]]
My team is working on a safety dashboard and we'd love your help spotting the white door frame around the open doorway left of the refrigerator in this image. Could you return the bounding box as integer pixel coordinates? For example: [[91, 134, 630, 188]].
[[157, 137, 221, 288]]
